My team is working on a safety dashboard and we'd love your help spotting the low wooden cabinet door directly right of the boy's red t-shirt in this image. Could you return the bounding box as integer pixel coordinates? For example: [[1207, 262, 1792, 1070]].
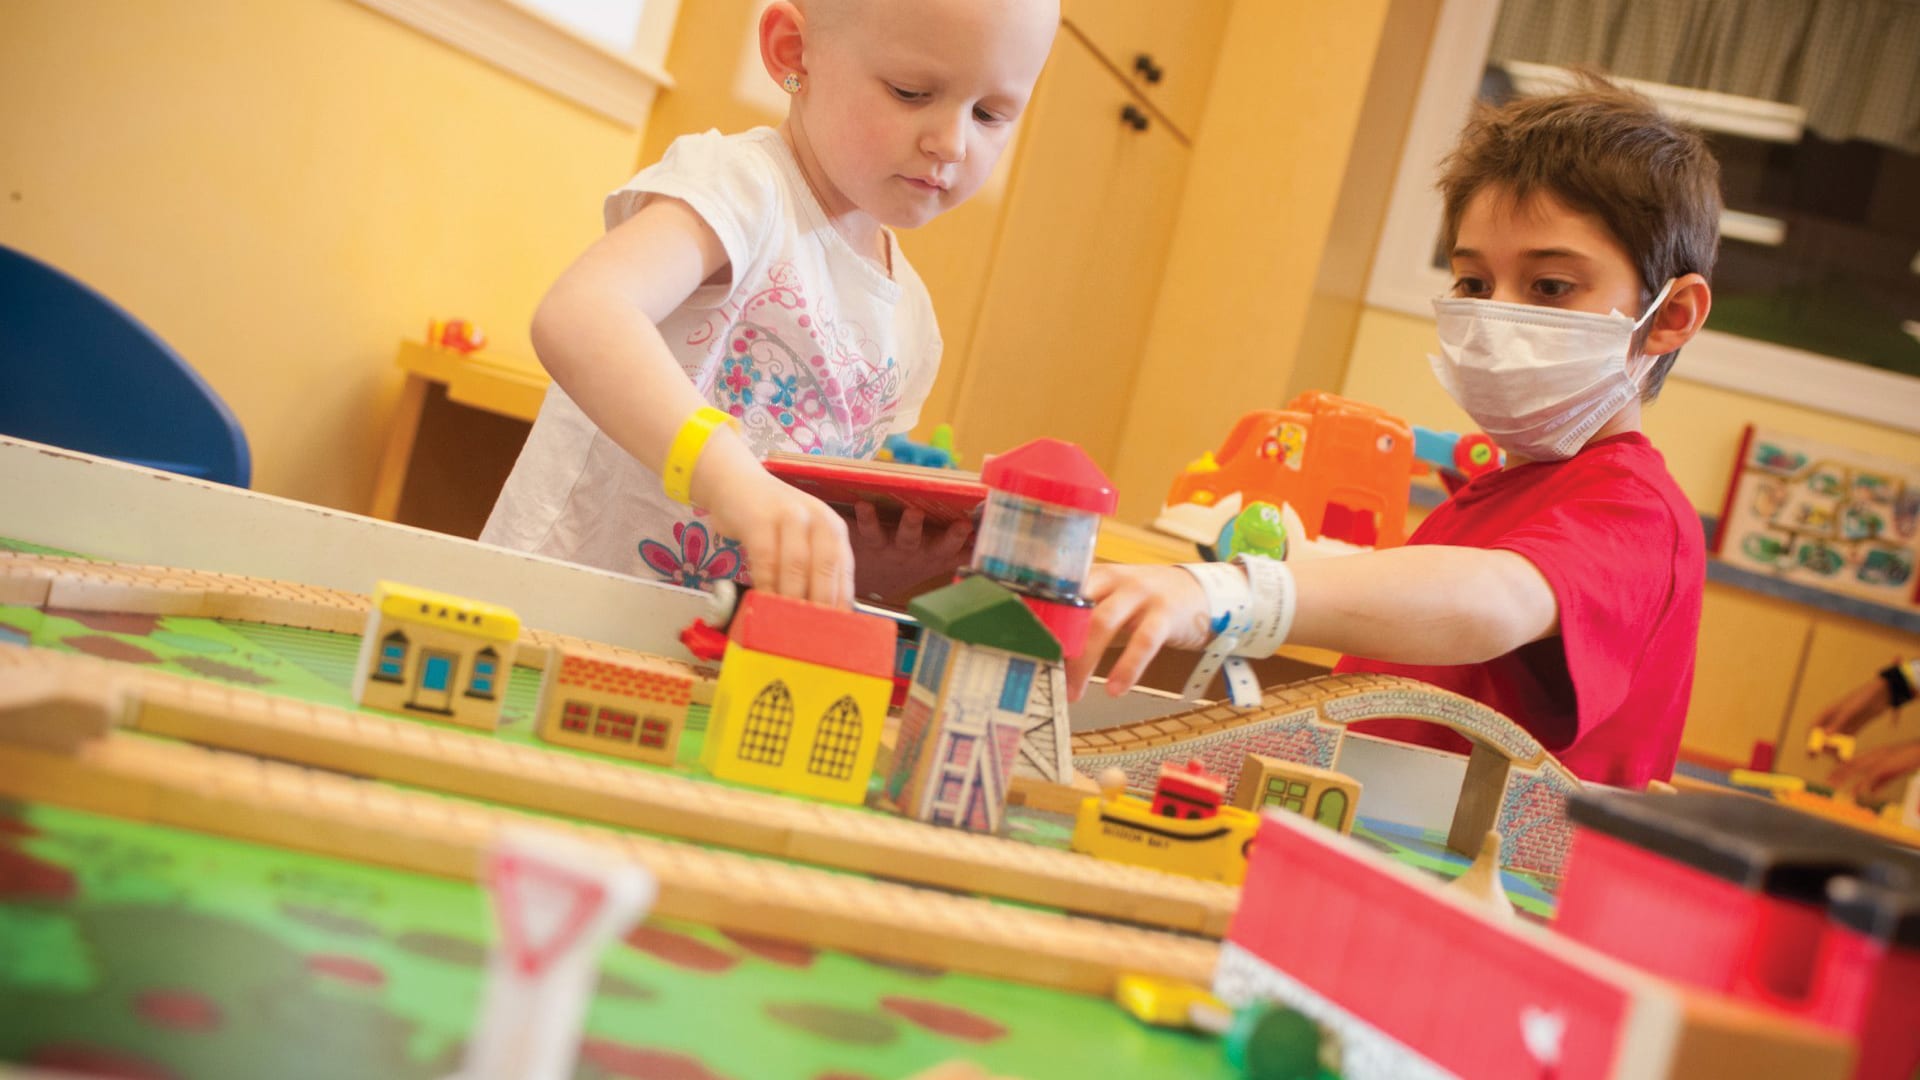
[[1680, 582, 1812, 767]]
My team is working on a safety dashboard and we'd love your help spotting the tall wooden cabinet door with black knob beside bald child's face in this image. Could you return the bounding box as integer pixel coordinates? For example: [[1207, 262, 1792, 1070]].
[[954, 37, 1187, 469]]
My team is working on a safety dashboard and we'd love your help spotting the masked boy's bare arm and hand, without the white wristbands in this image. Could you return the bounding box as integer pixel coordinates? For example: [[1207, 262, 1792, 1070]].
[[1068, 544, 1559, 700]]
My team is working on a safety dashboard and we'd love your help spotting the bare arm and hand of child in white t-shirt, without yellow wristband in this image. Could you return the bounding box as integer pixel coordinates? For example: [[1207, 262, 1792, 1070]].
[[534, 198, 852, 605]]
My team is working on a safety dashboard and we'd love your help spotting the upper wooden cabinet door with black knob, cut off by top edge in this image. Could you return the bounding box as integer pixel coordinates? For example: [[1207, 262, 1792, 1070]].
[[1062, 0, 1221, 138]]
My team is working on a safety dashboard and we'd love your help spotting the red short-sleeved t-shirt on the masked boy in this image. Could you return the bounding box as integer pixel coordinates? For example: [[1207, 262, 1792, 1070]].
[[1334, 432, 1707, 788]]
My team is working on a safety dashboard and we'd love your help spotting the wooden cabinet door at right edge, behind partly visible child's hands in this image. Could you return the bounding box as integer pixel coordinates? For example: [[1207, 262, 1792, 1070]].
[[1774, 617, 1920, 782]]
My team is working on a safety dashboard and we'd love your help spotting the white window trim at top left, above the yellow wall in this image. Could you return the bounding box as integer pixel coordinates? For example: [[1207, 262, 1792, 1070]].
[[359, 0, 678, 129]]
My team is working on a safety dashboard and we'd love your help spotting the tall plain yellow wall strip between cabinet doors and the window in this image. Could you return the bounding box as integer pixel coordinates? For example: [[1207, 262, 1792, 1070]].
[[1087, 0, 1434, 521]]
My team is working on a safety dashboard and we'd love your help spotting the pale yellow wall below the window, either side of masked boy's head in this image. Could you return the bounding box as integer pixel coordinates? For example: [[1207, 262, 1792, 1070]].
[[1340, 307, 1920, 515]]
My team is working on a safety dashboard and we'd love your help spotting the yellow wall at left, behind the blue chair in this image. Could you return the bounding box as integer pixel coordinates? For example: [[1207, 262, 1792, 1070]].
[[0, 0, 645, 509]]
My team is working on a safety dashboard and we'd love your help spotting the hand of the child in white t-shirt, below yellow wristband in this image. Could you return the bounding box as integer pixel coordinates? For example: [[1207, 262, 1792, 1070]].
[[693, 438, 852, 607]]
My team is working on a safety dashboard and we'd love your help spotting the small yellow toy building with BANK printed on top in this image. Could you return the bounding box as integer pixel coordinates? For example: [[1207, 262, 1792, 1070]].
[[353, 582, 520, 730]]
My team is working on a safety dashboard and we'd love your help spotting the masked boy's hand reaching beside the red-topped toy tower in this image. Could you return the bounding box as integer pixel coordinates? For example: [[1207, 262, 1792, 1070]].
[[1068, 565, 1212, 701]]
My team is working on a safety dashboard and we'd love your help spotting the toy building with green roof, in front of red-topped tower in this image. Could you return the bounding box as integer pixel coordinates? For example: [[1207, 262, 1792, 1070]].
[[887, 577, 1071, 832]]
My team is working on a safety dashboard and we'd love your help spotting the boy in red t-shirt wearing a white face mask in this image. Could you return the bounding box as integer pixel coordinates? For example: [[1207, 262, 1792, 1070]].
[[1068, 77, 1720, 788]]
